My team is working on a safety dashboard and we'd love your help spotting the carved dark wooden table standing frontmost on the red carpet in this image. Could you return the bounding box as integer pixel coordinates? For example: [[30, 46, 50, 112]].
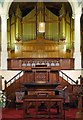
[[24, 95, 64, 118]]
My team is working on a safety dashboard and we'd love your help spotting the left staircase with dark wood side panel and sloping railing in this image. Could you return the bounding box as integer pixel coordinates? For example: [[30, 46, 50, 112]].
[[4, 71, 24, 100]]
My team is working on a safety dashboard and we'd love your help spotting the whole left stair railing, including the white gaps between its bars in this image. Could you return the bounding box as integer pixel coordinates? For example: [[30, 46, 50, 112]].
[[5, 71, 23, 89]]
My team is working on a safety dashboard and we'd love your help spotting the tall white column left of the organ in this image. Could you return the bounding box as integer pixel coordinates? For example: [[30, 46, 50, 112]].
[[1, 14, 8, 69]]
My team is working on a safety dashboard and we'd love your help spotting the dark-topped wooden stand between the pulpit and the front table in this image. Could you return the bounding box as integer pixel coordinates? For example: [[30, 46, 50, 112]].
[[23, 83, 59, 95]]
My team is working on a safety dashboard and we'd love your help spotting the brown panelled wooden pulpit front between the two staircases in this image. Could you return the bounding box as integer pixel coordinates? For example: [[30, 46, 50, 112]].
[[23, 67, 59, 87]]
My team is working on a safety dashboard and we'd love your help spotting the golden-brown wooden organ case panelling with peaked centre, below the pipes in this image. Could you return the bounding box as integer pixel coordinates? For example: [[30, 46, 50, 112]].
[[8, 36, 73, 58]]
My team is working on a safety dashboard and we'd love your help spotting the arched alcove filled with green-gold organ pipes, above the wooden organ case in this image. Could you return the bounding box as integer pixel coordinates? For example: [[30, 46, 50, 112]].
[[8, 1, 74, 57]]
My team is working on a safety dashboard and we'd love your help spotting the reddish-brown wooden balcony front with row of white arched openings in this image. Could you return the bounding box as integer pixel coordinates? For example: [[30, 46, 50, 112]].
[[8, 58, 74, 70]]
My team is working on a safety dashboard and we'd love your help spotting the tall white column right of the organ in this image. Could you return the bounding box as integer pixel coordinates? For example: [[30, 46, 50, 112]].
[[74, 7, 81, 69]]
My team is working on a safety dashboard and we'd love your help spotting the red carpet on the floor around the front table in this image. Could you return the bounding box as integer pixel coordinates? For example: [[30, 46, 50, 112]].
[[2, 108, 77, 120]]
